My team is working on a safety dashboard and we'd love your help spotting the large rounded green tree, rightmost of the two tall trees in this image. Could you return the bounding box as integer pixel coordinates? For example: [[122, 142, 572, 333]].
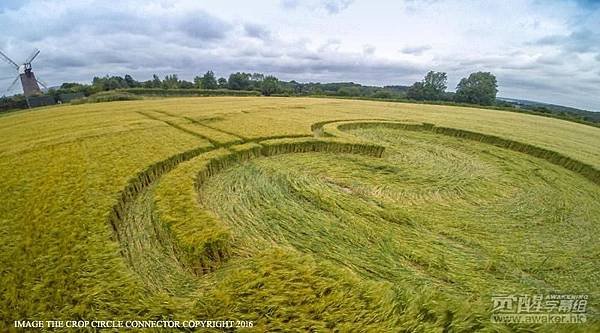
[[455, 72, 498, 105]]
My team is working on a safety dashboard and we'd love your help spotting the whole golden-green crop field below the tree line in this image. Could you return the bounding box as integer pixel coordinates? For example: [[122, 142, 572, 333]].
[[0, 97, 600, 332]]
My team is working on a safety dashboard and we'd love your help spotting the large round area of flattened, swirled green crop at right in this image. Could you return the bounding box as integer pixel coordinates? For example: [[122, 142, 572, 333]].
[[200, 127, 600, 320]]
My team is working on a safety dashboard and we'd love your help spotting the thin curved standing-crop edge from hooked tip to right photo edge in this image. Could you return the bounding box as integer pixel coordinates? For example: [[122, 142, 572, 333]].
[[321, 120, 600, 185]]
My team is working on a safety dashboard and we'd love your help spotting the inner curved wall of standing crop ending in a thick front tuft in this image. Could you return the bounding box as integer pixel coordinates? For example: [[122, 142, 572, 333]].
[[162, 138, 384, 274]]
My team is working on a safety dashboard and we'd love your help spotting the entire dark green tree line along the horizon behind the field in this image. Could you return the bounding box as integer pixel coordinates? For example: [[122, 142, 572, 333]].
[[0, 70, 600, 123]]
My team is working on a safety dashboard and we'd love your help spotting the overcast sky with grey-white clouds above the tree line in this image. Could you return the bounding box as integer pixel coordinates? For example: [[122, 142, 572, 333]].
[[0, 0, 600, 111]]
